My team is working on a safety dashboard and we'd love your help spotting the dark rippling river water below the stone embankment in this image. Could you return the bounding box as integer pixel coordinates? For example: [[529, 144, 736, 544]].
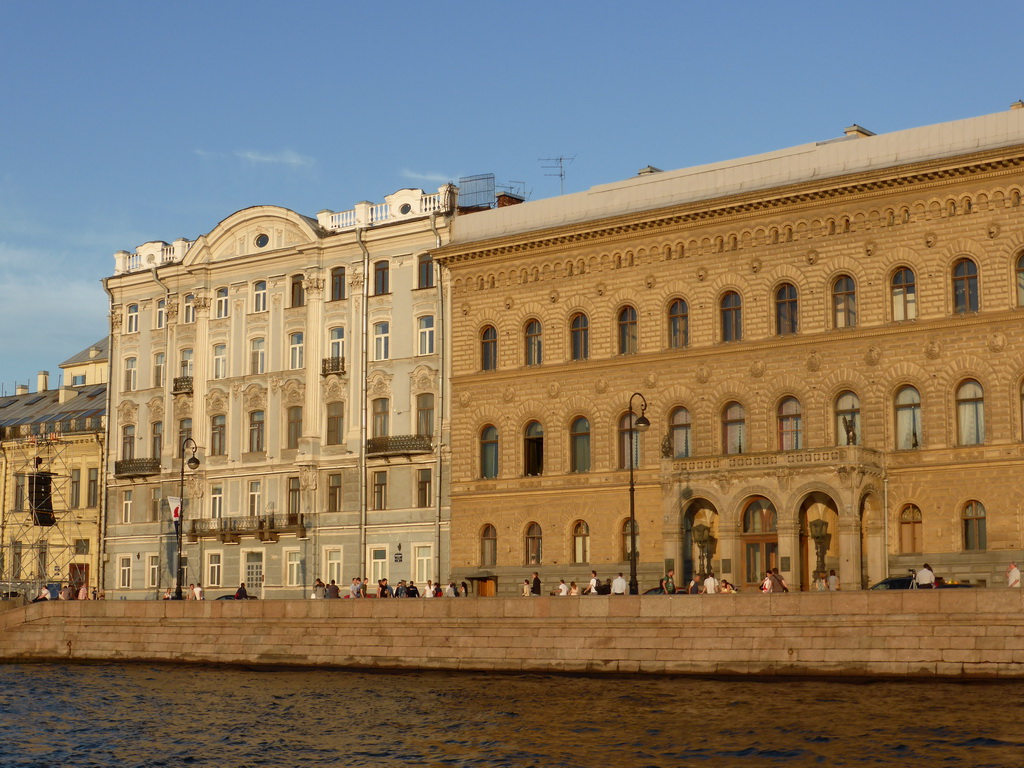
[[0, 665, 1024, 768]]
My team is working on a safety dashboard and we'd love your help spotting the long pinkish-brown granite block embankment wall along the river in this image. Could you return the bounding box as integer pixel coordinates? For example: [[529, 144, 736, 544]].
[[0, 589, 1024, 678]]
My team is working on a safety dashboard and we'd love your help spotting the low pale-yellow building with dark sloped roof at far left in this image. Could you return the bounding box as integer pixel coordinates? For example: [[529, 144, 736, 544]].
[[0, 339, 108, 598]]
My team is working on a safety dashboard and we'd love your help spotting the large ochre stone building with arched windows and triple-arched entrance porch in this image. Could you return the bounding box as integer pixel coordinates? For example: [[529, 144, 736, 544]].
[[435, 103, 1024, 594]]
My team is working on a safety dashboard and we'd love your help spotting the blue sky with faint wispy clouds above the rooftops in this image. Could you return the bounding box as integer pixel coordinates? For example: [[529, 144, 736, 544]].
[[0, 0, 1024, 393]]
